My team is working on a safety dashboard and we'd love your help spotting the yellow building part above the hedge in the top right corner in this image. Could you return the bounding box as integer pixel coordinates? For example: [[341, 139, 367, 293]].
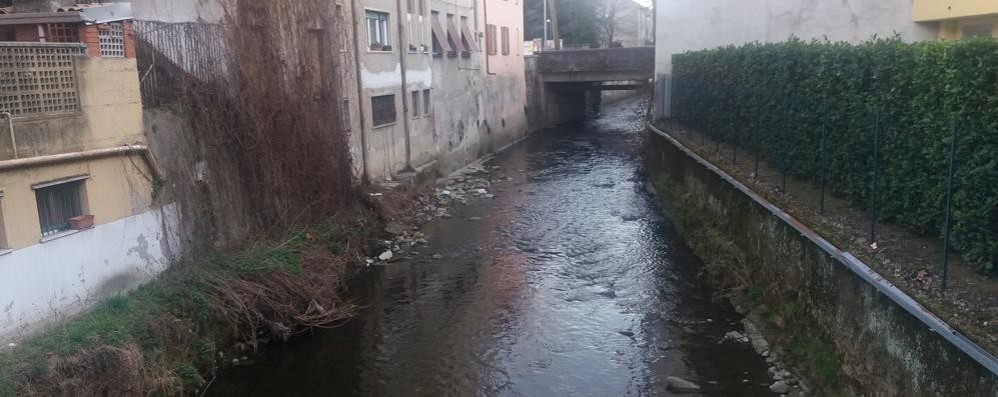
[[913, 0, 998, 40]]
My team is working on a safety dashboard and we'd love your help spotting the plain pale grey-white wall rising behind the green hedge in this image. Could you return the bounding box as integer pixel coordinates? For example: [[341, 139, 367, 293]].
[[655, 0, 936, 117]]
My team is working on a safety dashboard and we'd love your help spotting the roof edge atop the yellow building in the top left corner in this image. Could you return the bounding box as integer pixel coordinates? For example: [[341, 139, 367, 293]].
[[0, 3, 132, 26]]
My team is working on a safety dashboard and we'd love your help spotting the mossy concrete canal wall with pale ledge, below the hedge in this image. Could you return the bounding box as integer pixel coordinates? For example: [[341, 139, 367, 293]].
[[646, 128, 998, 396]]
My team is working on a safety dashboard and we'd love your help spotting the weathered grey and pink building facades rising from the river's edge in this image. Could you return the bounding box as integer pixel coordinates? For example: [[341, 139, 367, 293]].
[[344, 0, 526, 180]]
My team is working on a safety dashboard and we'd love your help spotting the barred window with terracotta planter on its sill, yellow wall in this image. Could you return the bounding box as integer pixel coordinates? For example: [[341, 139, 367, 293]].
[[35, 179, 83, 237]]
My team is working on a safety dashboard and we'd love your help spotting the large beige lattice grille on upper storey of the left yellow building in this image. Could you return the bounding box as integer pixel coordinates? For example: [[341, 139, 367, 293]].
[[0, 44, 85, 117]]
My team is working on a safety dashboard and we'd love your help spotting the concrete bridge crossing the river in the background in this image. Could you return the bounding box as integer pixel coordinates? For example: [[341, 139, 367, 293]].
[[525, 47, 655, 127]]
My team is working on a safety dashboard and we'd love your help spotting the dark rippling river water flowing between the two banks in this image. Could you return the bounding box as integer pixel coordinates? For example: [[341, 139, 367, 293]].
[[209, 100, 772, 396]]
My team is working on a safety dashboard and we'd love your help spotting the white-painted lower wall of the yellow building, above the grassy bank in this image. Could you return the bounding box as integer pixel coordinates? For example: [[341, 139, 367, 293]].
[[0, 205, 179, 338]]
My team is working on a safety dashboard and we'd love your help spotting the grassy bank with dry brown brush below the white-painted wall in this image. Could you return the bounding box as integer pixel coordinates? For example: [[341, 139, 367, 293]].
[[0, 222, 368, 396]]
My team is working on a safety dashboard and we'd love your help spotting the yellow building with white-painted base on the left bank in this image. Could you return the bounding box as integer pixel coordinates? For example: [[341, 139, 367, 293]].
[[0, 1, 173, 337]]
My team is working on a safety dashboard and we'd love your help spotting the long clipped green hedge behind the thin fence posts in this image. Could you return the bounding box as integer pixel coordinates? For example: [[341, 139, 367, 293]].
[[673, 39, 998, 276]]
